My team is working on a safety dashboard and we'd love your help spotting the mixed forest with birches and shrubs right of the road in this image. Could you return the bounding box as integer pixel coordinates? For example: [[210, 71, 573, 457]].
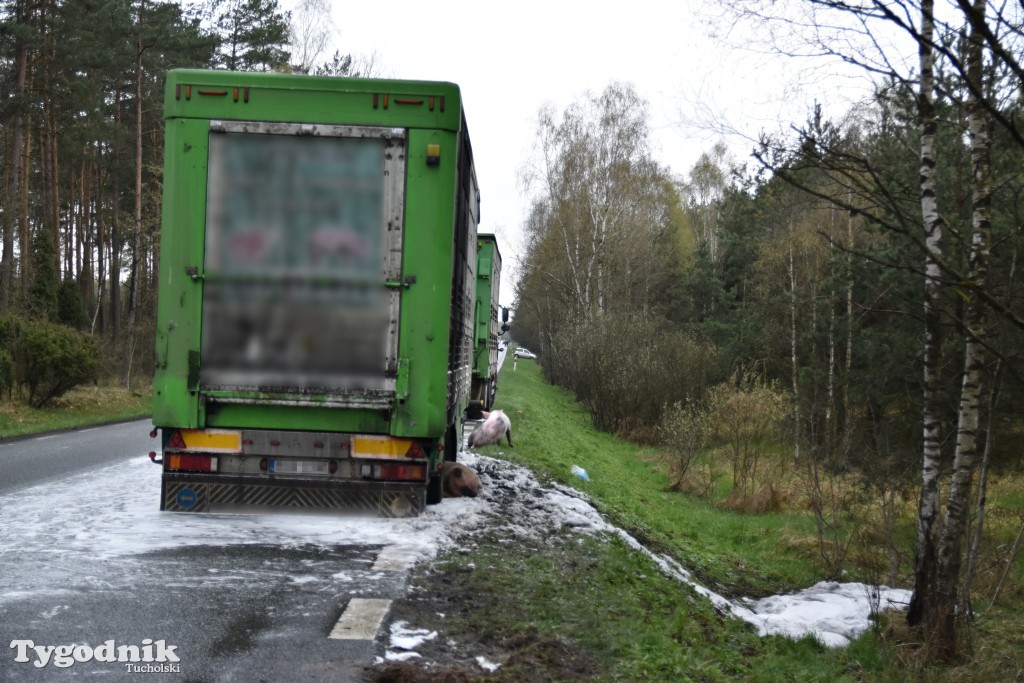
[[514, 0, 1024, 663]]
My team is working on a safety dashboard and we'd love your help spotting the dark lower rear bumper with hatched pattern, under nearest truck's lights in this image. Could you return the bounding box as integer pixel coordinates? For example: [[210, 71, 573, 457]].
[[160, 471, 427, 517]]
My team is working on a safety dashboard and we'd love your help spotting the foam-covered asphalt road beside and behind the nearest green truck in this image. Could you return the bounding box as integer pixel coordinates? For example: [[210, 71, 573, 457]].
[[0, 421, 421, 683]]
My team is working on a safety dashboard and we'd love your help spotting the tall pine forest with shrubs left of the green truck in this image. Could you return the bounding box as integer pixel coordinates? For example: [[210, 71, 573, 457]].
[[0, 0, 356, 405]]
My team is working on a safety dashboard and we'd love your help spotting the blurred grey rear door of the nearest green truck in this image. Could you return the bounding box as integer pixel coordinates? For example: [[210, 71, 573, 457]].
[[200, 121, 406, 408]]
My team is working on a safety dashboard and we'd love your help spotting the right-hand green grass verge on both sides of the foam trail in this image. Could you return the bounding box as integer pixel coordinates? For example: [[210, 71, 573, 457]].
[[395, 361, 1024, 683]]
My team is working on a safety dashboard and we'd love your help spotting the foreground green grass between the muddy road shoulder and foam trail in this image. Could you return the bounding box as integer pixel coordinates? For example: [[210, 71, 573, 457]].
[[417, 533, 881, 682]]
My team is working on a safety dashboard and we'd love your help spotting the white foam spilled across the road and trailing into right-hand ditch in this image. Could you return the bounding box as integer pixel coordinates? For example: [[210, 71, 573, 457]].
[[0, 453, 910, 646]]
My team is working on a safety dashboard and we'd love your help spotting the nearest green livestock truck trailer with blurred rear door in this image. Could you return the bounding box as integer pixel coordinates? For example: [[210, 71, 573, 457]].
[[154, 70, 487, 516]]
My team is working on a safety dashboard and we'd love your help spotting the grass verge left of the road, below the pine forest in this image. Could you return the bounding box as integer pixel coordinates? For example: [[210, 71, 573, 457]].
[[0, 386, 152, 438]]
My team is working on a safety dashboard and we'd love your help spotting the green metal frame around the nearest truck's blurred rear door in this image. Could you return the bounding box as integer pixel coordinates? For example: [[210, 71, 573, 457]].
[[154, 70, 476, 439]]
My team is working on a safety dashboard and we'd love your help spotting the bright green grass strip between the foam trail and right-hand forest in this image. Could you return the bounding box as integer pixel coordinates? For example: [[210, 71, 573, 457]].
[[481, 361, 821, 596]]
